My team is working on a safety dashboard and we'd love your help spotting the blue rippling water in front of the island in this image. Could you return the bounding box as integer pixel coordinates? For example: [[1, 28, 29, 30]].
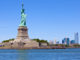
[[0, 49, 80, 60]]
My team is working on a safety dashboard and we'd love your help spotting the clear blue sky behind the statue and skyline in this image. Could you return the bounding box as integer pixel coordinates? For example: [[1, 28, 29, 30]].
[[0, 0, 80, 43]]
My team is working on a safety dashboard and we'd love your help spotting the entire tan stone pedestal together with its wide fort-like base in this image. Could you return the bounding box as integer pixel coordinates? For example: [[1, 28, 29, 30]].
[[10, 26, 39, 48]]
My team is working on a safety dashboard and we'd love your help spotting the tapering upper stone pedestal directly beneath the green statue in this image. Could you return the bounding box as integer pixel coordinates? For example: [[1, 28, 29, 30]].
[[15, 26, 30, 42]]
